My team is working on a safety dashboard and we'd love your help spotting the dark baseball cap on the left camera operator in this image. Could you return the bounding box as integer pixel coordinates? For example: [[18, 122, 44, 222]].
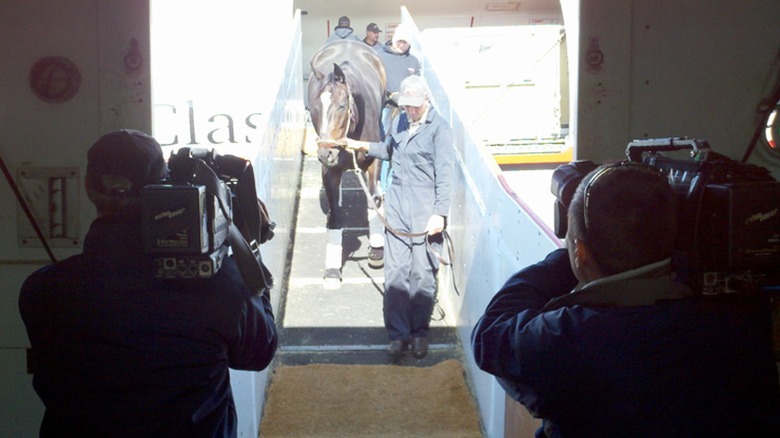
[[87, 129, 168, 196]]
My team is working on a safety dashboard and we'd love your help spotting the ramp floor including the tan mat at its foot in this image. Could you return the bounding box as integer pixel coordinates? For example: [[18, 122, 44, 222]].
[[260, 153, 482, 437]]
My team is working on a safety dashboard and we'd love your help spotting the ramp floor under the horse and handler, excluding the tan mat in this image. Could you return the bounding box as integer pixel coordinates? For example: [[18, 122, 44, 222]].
[[276, 157, 462, 366]]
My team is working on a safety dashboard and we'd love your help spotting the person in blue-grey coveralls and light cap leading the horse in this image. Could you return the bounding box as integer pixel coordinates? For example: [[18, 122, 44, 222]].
[[347, 76, 455, 358]]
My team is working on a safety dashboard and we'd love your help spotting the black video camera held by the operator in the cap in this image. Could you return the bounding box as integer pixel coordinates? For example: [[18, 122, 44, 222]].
[[141, 147, 275, 286]]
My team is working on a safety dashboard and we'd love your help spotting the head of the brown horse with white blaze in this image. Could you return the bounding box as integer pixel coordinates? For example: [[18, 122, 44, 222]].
[[309, 63, 357, 147]]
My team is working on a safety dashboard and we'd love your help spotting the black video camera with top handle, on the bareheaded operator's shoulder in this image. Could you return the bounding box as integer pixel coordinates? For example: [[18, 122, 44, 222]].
[[551, 137, 780, 293]]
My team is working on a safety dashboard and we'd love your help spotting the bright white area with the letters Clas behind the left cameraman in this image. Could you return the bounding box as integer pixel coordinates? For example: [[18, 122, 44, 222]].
[[151, 0, 290, 155]]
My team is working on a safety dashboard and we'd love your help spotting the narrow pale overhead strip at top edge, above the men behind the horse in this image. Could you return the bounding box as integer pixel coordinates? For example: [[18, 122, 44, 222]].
[[293, 0, 560, 20]]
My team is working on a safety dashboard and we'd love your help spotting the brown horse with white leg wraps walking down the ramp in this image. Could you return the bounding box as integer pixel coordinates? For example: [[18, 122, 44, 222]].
[[308, 40, 386, 289]]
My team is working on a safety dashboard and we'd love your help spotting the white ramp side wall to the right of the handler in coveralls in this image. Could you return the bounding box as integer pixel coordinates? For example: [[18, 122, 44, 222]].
[[402, 9, 561, 437]]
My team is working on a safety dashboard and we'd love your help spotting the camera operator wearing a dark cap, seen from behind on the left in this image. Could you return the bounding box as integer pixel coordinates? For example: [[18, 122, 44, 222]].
[[19, 129, 277, 437]]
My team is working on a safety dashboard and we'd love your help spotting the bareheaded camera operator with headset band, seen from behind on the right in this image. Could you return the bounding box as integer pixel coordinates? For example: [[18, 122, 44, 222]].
[[472, 162, 780, 437]]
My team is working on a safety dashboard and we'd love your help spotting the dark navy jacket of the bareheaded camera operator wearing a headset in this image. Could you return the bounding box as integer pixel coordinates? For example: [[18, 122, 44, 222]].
[[472, 249, 780, 437]]
